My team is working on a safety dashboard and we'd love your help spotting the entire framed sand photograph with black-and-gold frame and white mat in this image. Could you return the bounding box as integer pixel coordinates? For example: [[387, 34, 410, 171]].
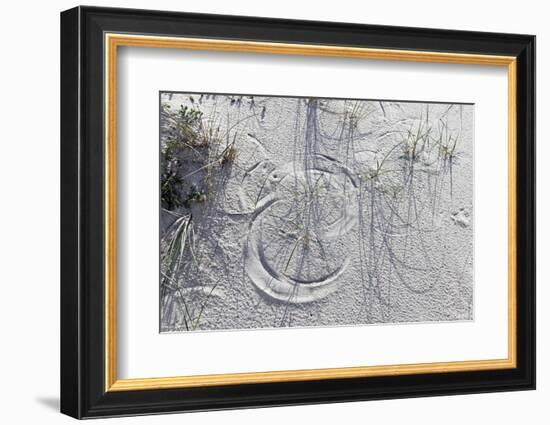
[[61, 7, 535, 418]]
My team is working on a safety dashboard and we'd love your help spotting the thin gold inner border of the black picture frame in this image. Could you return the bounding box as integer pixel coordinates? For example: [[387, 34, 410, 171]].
[[104, 33, 517, 391]]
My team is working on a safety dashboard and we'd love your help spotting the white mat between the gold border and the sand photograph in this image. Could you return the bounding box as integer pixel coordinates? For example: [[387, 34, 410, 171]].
[[117, 48, 508, 378]]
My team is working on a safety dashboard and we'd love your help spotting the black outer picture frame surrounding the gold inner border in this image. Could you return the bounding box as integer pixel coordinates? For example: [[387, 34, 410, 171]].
[[61, 7, 535, 418]]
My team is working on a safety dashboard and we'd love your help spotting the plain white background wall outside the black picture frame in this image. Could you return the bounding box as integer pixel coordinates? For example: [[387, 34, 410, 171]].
[[0, 0, 550, 424]]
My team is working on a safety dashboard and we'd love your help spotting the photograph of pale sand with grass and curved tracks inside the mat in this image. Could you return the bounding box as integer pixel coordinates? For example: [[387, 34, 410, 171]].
[[159, 91, 475, 332]]
